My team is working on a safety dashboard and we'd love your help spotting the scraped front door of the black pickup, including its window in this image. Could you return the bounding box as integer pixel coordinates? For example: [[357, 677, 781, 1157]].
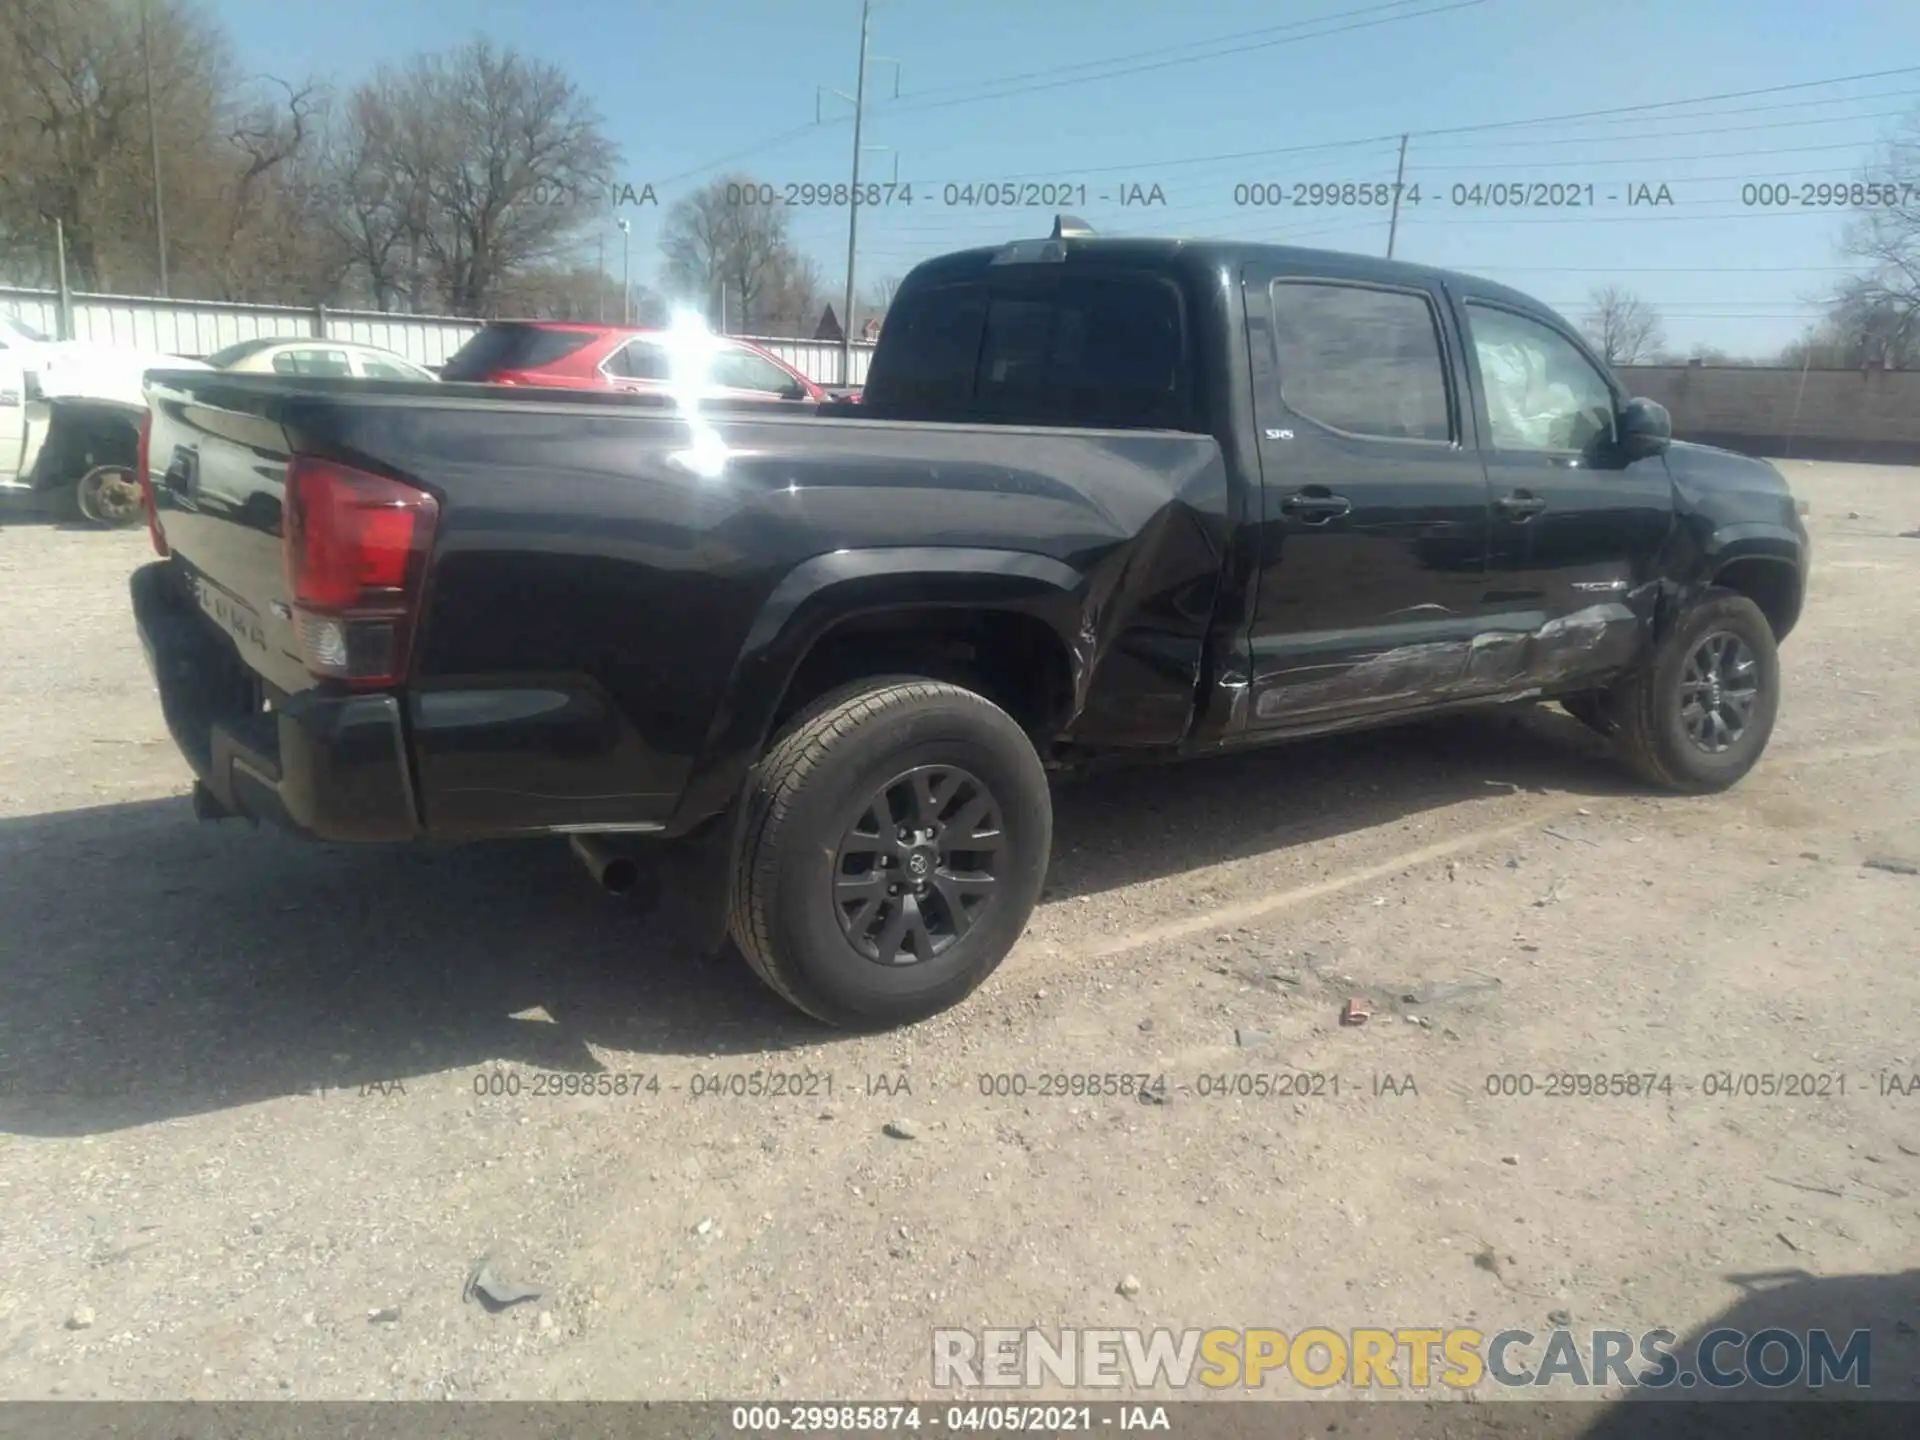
[[1461, 296, 1672, 691]]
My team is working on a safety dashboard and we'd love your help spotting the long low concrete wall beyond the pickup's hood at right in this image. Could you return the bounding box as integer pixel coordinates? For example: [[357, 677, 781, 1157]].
[[1619, 365, 1920, 465]]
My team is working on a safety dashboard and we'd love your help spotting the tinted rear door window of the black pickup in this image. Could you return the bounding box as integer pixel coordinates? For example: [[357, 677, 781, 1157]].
[[1273, 280, 1453, 442]]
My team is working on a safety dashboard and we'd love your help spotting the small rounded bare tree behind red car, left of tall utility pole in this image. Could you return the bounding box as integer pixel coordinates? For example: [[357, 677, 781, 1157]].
[[660, 175, 822, 334]]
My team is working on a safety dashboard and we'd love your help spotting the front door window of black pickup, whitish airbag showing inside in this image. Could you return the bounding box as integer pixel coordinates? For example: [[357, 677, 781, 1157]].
[[1467, 303, 1613, 453]]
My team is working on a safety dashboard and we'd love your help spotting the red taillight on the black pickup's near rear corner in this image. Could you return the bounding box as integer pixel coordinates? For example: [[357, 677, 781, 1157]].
[[282, 455, 440, 685]]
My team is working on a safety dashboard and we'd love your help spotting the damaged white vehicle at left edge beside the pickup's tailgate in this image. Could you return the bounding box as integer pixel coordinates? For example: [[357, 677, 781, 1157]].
[[0, 315, 209, 524]]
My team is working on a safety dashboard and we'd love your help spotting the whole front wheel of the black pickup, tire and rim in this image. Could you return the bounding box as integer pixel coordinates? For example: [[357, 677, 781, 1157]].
[[1607, 589, 1780, 793]]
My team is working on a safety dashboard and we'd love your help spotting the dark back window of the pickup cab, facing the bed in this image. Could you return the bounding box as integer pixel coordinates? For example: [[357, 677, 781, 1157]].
[[864, 275, 1188, 428]]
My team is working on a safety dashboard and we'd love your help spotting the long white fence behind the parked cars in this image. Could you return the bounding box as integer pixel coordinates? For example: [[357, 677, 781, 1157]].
[[0, 288, 874, 384]]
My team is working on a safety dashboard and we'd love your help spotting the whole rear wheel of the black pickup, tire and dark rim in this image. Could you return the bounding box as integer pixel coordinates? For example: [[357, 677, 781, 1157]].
[[730, 678, 1052, 1029]]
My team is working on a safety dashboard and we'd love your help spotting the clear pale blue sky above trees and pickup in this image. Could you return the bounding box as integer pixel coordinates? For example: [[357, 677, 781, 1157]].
[[211, 0, 1920, 353]]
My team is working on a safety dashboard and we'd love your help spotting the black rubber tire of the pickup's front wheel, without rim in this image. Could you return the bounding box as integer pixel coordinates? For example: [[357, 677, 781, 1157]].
[[1607, 589, 1780, 795]]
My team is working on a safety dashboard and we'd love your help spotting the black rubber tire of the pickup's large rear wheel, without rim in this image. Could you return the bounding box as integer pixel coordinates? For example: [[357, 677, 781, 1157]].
[[730, 676, 1054, 1029]]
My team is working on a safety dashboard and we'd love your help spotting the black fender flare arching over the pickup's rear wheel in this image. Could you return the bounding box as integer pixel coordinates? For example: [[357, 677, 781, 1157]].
[[668, 545, 1089, 835]]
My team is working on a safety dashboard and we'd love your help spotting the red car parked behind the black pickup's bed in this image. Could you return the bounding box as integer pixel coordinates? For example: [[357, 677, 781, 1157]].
[[440, 321, 828, 403]]
